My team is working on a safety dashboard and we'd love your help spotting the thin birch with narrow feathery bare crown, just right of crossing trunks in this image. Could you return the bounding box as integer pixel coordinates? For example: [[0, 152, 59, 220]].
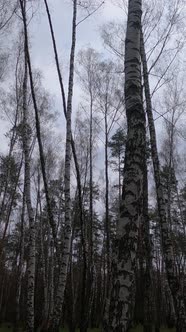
[[77, 49, 98, 332]]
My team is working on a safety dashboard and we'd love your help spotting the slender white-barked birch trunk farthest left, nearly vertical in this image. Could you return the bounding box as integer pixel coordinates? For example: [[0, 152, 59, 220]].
[[22, 29, 35, 332]]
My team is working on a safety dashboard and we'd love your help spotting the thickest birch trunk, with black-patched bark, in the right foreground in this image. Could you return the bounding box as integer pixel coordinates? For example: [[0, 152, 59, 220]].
[[109, 0, 145, 332]]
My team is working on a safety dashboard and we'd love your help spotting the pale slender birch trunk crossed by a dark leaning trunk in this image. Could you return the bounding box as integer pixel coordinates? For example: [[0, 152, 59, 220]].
[[51, 0, 77, 332]]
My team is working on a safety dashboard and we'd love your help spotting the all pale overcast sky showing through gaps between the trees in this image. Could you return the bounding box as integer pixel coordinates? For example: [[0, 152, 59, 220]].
[[0, 0, 185, 211]]
